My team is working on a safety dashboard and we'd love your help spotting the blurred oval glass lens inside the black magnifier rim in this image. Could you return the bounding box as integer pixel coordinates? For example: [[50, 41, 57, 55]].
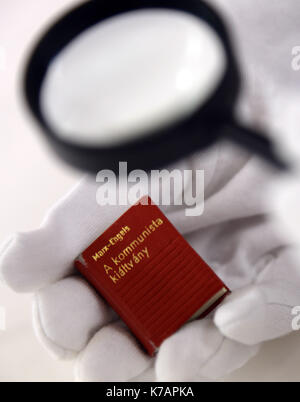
[[40, 9, 227, 146]]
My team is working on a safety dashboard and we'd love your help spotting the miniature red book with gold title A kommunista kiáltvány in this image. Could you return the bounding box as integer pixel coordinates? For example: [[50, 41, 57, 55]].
[[75, 197, 230, 355]]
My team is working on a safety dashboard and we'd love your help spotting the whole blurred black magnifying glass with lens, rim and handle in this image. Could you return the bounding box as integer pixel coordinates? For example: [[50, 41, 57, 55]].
[[24, 0, 287, 173]]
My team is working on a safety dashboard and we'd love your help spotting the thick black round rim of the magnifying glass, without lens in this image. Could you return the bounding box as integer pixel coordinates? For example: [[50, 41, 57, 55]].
[[24, 0, 240, 172]]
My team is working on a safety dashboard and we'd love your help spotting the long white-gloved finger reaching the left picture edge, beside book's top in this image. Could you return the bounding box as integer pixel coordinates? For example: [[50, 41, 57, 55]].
[[0, 178, 127, 292]]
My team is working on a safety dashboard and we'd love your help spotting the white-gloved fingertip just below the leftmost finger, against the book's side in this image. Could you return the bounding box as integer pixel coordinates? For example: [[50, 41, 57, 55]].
[[34, 276, 115, 359]]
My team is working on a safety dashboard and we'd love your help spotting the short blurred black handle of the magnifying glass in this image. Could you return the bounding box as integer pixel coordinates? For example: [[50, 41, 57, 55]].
[[222, 121, 291, 171]]
